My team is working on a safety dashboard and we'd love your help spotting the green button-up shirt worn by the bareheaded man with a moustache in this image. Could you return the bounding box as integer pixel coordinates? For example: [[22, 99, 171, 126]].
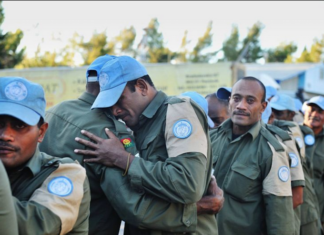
[[211, 119, 294, 235]]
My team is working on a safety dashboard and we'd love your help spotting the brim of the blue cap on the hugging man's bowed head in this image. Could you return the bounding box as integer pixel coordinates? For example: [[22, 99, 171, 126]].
[[91, 82, 127, 109]]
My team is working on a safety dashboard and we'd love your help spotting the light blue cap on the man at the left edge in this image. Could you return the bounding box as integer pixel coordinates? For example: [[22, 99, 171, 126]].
[[0, 77, 46, 126]]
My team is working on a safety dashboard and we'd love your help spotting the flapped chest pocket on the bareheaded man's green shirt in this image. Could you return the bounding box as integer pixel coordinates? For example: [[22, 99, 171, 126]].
[[224, 161, 262, 202]]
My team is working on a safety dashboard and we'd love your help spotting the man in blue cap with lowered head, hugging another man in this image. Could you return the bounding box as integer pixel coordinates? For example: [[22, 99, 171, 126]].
[[76, 56, 217, 234]]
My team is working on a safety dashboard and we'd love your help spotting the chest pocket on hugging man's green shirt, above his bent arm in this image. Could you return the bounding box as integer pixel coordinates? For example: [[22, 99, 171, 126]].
[[140, 134, 168, 162]]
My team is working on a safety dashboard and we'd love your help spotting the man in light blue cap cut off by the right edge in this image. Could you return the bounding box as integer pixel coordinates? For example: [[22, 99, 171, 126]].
[[304, 96, 324, 228]]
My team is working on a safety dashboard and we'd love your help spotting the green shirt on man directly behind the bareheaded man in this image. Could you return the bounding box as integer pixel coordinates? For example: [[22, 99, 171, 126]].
[[273, 120, 319, 232]]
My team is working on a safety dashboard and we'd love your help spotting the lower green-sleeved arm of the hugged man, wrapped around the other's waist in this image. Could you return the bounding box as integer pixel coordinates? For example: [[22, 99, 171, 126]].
[[101, 168, 197, 233]]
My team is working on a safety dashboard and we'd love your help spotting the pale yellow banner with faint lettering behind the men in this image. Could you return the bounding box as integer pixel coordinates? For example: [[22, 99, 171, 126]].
[[0, 63, 232, 108]]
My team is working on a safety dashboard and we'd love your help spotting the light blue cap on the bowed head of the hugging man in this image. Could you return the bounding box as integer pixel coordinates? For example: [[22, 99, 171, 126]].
[[91, 56, 147, 109]]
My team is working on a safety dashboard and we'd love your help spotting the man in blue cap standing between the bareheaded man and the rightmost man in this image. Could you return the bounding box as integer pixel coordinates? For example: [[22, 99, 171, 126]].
[[270, 94, 320, 235]]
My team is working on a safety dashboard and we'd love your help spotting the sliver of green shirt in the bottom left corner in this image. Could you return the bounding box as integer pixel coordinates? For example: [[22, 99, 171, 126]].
[[0, 160, 18, 235]]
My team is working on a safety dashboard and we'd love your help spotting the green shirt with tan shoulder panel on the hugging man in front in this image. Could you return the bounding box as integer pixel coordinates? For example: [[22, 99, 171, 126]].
[[128, 91, 217, 234]]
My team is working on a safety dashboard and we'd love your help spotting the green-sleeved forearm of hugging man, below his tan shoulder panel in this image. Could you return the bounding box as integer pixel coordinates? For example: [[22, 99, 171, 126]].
[[128, 154, 207, 204]]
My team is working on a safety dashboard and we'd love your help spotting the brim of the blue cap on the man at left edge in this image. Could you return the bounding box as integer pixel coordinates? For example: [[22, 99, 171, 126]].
[[0, 102, 41, 126]]
